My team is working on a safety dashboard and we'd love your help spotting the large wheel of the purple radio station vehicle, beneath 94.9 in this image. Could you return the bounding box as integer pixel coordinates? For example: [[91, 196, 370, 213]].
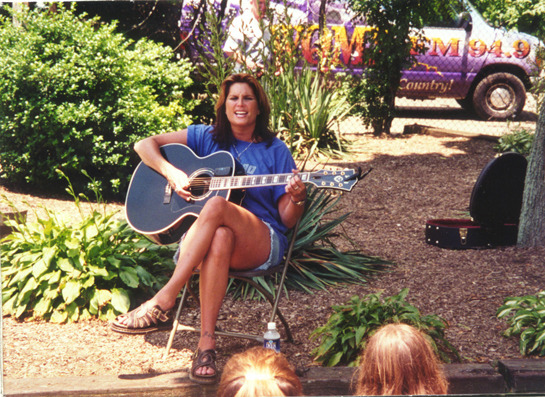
[[473, 73, 526, 120]]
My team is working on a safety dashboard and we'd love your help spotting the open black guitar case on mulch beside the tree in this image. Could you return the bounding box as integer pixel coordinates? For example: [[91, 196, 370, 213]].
[[426, 153, 527, 249]]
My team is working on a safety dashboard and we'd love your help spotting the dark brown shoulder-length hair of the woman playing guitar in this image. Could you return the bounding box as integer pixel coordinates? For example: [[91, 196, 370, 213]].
[[214, 73, 274, 147]]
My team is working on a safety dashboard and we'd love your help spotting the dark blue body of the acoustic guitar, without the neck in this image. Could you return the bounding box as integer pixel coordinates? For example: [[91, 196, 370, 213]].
[[125, 143, 237, 245]]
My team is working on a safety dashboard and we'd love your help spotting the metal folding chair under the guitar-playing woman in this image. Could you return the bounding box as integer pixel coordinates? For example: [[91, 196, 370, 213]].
[[163, 221, 299, 358]]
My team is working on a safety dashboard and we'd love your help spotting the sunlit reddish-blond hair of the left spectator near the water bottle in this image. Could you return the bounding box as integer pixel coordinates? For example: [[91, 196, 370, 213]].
[[217, 347, 303, 397]]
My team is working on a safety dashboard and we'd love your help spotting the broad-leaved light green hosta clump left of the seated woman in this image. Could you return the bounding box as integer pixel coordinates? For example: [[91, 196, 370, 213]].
[[0, 170, 173, 322]]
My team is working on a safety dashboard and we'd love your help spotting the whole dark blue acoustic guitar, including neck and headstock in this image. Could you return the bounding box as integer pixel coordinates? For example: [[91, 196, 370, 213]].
[[125, 143, 370, 245]]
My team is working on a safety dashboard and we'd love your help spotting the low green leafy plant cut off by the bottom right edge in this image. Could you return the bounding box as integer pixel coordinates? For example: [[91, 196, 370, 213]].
[[496, 291, 545, 356]]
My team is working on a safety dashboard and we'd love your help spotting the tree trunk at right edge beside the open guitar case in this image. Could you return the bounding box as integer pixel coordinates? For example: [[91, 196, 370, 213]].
[[517, 101, 545, 247]]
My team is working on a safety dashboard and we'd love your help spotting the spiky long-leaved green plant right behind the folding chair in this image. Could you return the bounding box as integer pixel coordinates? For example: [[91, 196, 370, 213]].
[[226, 189, 392, 298]]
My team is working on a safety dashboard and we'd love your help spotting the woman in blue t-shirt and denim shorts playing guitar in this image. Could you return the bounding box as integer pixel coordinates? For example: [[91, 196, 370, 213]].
[[112, 74, 306, 383]]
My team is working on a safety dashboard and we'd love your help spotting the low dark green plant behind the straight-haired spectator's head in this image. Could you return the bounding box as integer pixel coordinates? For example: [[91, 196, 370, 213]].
[[311, 288, 460, 367]]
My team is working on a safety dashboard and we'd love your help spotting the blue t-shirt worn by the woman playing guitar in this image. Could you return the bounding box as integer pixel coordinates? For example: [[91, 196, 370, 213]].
[[187, 124, 296, 252]]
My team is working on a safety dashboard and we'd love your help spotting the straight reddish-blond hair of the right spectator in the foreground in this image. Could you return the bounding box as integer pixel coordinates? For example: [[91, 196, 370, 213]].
[[356, 324, 448, 396]]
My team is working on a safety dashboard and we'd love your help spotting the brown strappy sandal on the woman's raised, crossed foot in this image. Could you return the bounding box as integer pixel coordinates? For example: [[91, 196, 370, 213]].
[[110, 304, 173, 335]]
